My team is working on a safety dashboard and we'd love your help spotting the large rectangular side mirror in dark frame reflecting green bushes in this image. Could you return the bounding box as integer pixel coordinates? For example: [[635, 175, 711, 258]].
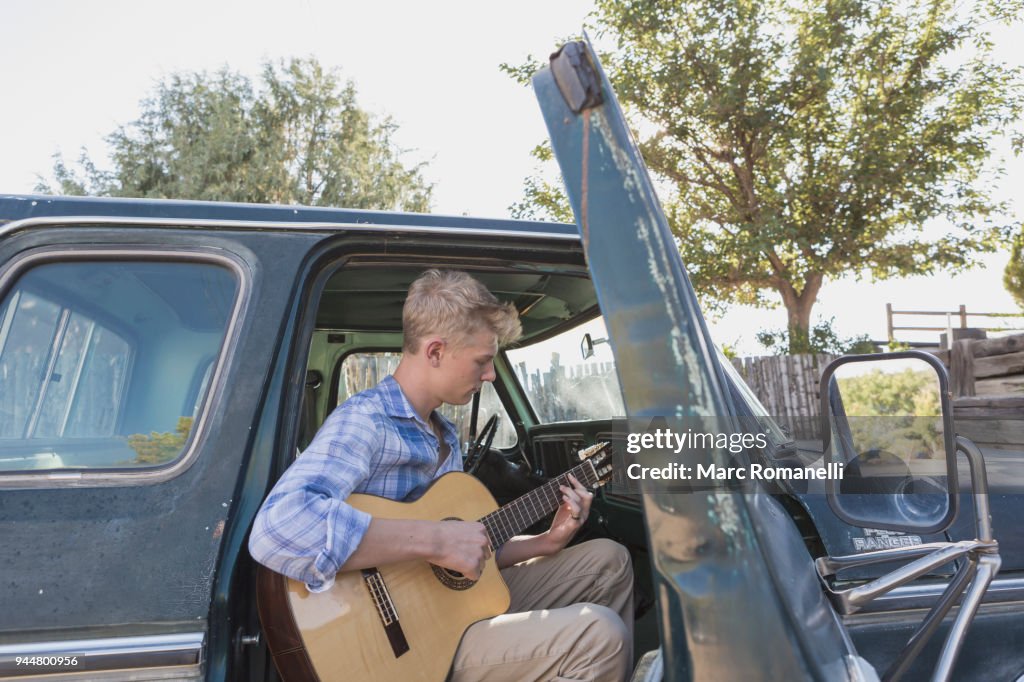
[[819, 350, 958, 535]]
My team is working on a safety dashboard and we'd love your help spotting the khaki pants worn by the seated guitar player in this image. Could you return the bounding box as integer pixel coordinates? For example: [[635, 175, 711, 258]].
[[451, 540, 633, 682]]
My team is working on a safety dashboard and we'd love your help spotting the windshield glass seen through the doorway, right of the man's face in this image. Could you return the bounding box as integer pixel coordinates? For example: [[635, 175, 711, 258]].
[[506, 317, 626, 423]]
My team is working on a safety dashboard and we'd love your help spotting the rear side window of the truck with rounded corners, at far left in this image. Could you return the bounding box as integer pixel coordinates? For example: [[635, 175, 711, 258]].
[[0, 261, 238, 471]]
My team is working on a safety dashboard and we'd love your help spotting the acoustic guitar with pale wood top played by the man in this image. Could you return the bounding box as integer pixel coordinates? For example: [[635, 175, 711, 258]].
[[257, 442, 611, 682]]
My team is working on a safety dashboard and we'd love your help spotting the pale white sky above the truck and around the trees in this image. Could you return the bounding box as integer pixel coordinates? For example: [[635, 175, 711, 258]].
[[0, 0, 1024, 354]]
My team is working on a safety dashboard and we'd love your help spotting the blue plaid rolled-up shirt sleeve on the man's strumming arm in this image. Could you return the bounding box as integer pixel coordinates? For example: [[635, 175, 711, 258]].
[[249, 403, 386, 592]]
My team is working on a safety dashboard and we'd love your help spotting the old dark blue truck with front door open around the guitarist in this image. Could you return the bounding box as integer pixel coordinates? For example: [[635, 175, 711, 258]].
[[0, 43, 1024, 681]]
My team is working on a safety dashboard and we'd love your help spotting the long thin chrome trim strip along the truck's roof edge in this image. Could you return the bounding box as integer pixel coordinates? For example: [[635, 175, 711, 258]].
[[0, 215, 580, 242]]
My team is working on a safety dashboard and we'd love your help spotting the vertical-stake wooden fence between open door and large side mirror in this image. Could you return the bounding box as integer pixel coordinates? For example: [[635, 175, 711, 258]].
[[732, 353, 839, 440]]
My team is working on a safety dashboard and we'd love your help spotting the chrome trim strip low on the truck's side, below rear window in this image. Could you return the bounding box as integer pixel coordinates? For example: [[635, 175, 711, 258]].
[[0, 632, 206, 680]]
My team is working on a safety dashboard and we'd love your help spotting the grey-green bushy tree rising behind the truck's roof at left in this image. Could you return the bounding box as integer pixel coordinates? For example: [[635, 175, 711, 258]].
[[37, 58, 431, 211]]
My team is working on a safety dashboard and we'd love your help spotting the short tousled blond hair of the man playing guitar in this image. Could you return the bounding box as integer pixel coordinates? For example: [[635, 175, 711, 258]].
[[401, 269, 522, 353]]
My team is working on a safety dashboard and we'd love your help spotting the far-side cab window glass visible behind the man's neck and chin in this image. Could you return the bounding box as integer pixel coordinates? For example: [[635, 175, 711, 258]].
[[338, 352, 518, 454]]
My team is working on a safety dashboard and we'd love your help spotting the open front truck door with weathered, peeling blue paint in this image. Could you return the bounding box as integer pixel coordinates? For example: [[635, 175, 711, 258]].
[[534, 42, 998, 680]]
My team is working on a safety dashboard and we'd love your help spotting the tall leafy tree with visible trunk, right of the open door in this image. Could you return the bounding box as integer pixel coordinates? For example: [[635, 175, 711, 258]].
[[504, 0, 1022, 352]]
